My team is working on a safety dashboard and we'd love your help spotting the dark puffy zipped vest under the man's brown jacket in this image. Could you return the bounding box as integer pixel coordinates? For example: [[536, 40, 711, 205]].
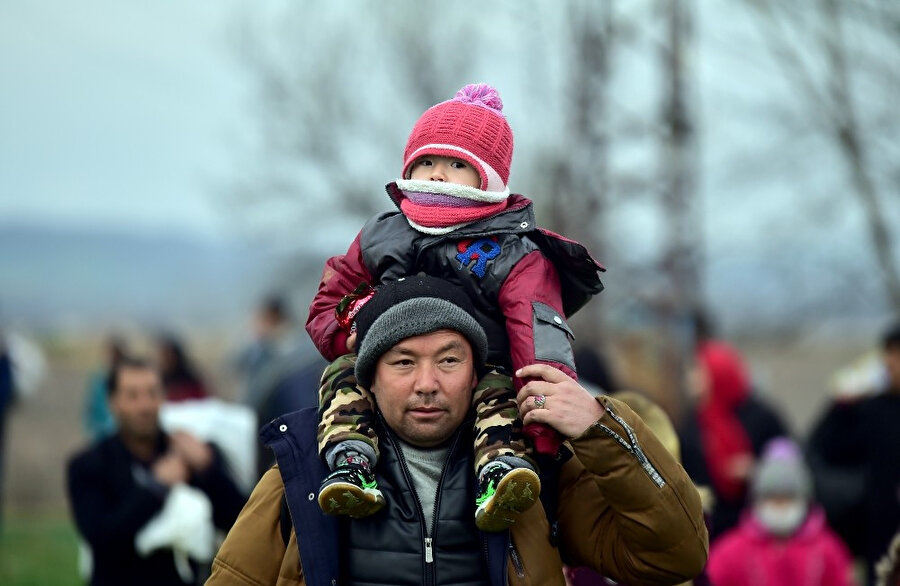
[[341, 422, 490, 586]]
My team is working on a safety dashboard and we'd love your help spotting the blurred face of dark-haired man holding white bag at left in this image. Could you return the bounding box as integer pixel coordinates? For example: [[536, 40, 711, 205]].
[[109, 367, 165, 440]]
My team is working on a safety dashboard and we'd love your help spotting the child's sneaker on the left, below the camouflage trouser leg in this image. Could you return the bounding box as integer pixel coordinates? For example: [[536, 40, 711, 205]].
[[319, 462, 384, 518]]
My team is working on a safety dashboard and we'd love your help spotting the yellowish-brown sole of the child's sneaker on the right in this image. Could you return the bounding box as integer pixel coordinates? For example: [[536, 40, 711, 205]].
[[475, 468, 541, 532]]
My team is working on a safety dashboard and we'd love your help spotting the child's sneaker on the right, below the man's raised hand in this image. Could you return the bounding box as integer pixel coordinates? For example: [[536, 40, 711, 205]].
[[475, 460, 541, 532]]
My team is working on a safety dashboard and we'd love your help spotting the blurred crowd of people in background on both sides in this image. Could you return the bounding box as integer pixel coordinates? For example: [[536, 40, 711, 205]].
[[0, 297, 900, 586]]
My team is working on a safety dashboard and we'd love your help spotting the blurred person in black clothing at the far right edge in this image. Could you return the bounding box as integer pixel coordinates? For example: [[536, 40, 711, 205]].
[[809, 321, 900, 584]]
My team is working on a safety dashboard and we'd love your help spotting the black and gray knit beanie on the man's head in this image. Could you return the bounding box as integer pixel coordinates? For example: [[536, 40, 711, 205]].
[[355, 275, 488, 387]]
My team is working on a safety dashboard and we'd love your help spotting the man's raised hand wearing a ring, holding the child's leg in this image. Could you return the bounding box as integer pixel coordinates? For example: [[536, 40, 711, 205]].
[[516, 364, 605, 438]]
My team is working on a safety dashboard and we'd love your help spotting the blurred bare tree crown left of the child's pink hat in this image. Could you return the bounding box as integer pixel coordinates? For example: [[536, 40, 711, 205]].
[[229, 3, 470, 248]]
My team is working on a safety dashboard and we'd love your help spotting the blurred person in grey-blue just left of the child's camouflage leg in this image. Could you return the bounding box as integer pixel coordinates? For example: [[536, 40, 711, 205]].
[[236, 295, 326, 477]]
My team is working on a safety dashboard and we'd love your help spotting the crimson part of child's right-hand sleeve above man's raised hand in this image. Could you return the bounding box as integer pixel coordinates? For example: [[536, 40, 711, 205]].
[[499, 251, 577, 390]]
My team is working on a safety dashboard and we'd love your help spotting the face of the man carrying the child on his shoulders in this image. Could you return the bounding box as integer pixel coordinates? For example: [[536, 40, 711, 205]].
[[372, 330, 478, 448]]
